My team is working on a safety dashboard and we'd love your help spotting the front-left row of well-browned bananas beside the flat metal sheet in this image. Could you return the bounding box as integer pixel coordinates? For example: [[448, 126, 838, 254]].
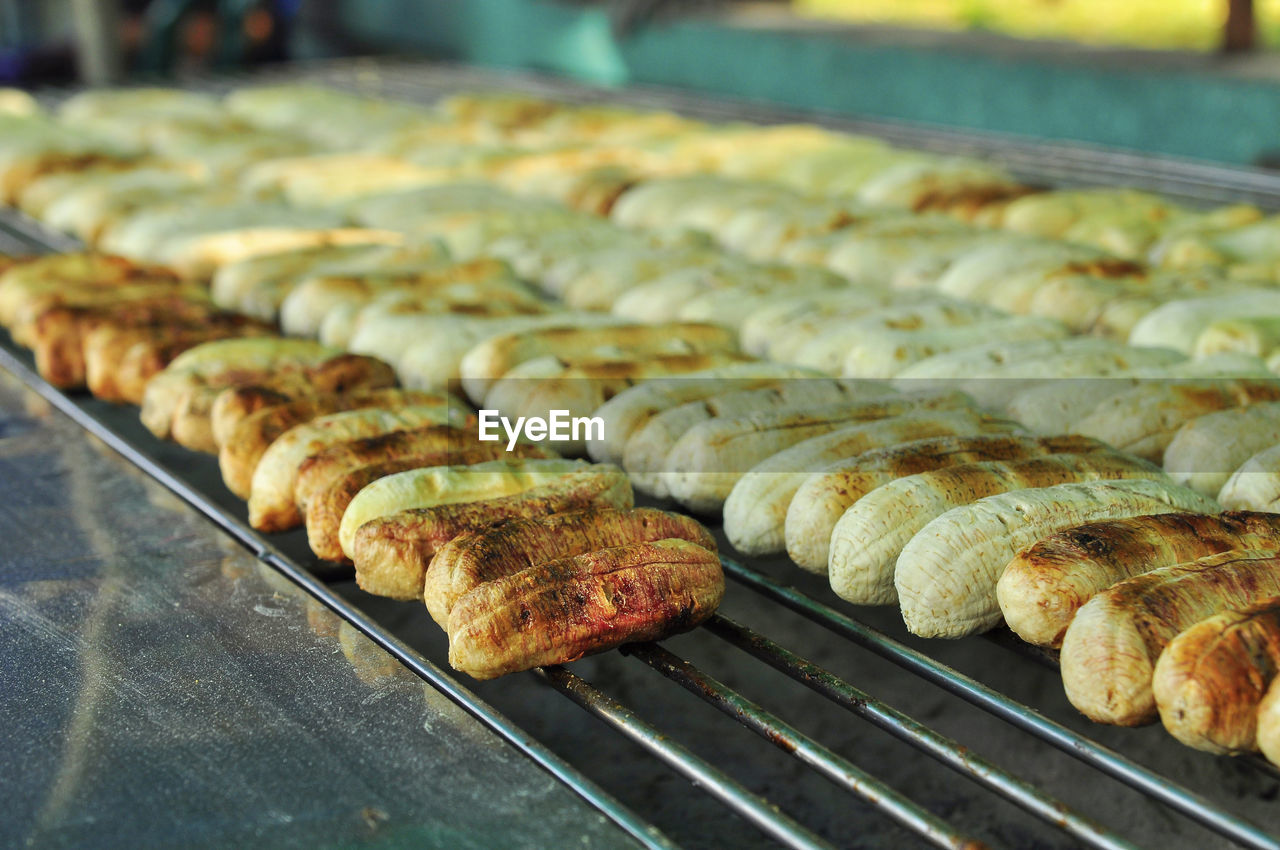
[[0, 255, 723, 678]]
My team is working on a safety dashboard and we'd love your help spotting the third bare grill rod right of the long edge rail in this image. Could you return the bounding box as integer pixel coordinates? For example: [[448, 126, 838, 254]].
[[704, 614, 1137, 849]]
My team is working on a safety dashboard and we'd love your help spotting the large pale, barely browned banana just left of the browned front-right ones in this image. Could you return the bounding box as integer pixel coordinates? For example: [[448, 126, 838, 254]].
[[896, 479, 1217, 638]]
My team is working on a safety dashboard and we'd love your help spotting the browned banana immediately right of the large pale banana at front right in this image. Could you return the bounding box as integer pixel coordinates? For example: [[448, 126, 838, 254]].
[[996, 511, 1280, 646]]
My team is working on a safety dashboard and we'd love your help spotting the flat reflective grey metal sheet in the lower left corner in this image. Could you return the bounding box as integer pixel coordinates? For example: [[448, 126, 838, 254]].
[[0, 371, 645, 847]]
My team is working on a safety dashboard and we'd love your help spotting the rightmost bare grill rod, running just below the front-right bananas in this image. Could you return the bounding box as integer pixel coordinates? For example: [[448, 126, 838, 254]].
[[721, 557, 1280, 850]]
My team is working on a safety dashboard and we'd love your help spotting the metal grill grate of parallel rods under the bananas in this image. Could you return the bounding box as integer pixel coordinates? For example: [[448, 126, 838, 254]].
[[0, 60, 1280, 849]]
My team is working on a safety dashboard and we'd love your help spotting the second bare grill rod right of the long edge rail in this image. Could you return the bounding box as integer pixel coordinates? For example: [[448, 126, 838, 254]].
[[622, 644, 987, 850]]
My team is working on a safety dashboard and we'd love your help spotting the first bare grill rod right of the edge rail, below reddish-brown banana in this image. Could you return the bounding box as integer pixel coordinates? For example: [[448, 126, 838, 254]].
[[535, 666, 833, 850]]
